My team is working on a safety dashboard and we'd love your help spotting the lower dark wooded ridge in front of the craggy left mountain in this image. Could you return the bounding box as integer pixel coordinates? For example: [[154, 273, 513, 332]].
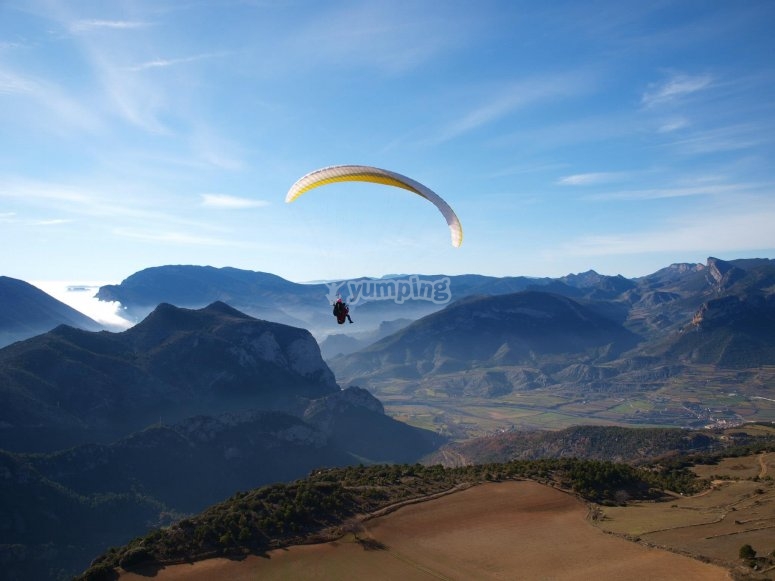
[[0, 388, 444, 579]]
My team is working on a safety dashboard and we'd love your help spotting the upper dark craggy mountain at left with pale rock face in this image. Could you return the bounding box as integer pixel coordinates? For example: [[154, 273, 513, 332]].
[[0, 302, 339, 450]]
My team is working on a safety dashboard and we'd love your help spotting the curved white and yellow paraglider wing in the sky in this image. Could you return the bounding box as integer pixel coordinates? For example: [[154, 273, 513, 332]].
[[285, 165, 463, 247]]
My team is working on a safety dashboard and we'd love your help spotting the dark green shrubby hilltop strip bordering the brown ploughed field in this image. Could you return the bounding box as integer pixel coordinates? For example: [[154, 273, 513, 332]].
[[77, 428, 775, 579]]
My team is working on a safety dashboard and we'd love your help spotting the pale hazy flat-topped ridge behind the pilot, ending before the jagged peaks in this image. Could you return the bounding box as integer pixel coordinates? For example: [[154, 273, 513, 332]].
[[96, 265, 571, 342]]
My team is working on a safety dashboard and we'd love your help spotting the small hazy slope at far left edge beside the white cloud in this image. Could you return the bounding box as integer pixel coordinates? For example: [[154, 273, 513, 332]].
[[0, 276, 102, 347]]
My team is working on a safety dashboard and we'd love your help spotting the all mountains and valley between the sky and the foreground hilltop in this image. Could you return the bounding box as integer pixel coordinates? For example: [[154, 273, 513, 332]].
[[0, 258, 775, 578]]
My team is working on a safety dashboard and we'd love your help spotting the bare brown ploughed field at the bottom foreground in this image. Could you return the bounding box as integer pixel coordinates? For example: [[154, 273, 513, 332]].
[[121, 481, 731, 581]]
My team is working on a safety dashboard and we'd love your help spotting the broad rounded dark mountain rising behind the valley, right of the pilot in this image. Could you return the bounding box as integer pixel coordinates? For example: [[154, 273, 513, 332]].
[[332, 291, 637, 389]]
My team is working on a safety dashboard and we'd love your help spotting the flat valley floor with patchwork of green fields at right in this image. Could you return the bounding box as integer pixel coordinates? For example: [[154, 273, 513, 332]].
[[377, 376, 775, 440]]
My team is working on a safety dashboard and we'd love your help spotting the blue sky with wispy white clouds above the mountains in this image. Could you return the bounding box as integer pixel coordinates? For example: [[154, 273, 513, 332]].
[[0, 0, 775, 282]]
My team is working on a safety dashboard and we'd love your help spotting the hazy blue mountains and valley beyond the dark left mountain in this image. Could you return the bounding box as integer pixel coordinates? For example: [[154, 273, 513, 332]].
[[3, 257, 775, 422]]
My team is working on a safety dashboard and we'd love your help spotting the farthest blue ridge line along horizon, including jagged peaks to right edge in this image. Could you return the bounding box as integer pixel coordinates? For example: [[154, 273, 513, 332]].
[[88, 257, 773, 342]]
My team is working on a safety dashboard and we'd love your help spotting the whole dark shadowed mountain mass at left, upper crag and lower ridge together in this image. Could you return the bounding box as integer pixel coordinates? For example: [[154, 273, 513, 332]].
[[0, 302, 446, 579]]
